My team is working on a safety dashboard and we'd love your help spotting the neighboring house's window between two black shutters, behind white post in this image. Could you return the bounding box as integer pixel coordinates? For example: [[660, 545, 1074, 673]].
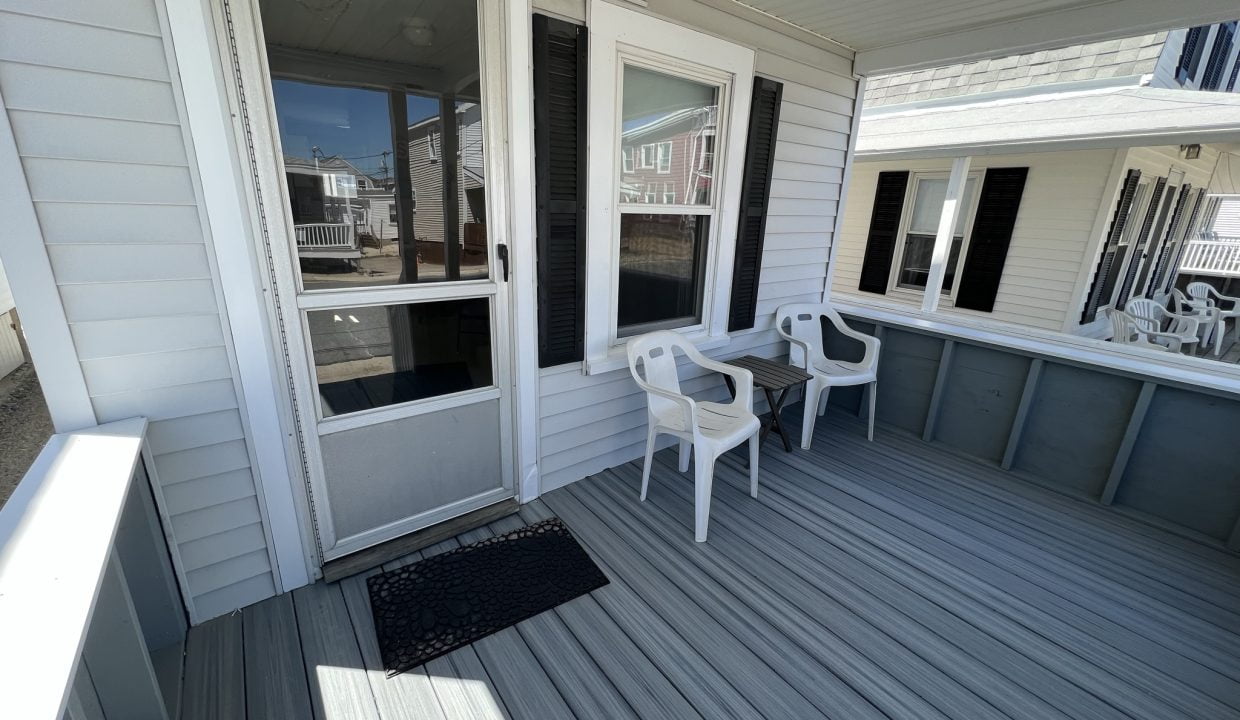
[[894, 175, 980, 295]]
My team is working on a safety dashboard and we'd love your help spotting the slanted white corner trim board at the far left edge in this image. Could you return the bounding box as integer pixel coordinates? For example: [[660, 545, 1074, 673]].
[[0, 84, 97, 432]]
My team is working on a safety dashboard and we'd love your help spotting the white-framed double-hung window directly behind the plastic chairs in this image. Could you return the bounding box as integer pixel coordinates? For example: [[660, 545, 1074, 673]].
[[584, 0, 754, 373]]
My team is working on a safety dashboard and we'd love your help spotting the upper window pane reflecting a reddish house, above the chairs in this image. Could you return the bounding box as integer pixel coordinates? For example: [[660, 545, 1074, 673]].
[[620, 66, 719, 204]]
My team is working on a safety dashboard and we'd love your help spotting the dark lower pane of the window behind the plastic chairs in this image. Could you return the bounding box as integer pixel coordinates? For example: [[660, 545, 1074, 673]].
[[616, 213, 711, 337]]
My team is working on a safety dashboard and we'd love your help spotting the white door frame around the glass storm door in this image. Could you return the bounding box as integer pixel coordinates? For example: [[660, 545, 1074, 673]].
[[186, 0, 538, 566]]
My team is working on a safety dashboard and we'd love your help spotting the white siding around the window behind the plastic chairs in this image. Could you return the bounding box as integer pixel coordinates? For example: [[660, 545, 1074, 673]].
[[539, 2, 857, 492]]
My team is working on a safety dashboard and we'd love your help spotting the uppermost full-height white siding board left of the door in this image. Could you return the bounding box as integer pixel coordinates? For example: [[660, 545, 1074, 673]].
[[0, 12, 169, 79]]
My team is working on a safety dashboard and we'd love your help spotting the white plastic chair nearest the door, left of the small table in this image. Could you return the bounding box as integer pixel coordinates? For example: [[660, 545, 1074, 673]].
[[627, 330, 761, 543]]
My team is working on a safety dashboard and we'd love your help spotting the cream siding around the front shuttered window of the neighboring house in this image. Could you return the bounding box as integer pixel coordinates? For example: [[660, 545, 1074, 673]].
[[832, 150, 1115, 330]]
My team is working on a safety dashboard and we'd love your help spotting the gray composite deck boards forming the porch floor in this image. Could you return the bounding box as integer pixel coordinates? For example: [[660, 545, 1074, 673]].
[[181, 413, 1240, 720]]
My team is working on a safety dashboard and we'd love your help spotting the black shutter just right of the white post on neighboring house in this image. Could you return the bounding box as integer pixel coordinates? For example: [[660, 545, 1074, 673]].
[[956, 167, 1029, 312]]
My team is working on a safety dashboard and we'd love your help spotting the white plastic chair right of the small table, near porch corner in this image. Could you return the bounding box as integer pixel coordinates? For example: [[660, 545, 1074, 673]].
[[775, 302, 880, 450]]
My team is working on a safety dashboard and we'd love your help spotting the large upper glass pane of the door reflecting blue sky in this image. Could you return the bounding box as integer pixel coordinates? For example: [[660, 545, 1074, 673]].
[[260, 0, 487, 290]]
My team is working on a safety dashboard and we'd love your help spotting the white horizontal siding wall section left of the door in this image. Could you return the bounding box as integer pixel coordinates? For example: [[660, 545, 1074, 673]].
[[0, 0, 275, 620]]
